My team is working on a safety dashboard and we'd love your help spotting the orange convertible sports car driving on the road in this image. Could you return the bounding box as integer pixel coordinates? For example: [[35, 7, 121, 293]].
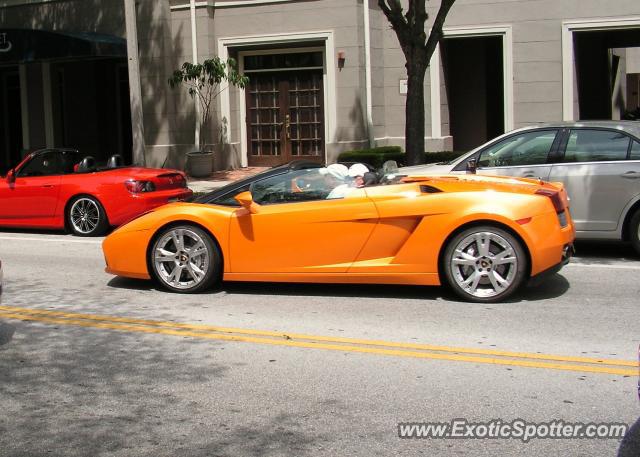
[[103, 162, 575, 302]]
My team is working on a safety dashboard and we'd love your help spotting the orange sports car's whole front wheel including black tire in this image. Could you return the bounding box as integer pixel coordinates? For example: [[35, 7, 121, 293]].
[[147, 224, 222, 294]]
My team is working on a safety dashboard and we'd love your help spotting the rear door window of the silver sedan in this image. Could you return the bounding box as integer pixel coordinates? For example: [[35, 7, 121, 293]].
[[563, 130, 631, 162]]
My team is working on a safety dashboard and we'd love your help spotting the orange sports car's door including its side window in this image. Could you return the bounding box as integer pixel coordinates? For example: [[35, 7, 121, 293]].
[[229, 168, 378, 273]]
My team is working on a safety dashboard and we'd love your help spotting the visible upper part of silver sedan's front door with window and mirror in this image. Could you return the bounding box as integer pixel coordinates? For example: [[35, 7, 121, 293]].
[[454, 128, 559, 180]]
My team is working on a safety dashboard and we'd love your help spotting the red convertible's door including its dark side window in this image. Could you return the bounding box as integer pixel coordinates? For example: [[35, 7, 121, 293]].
[[0, 151, 62, 221]]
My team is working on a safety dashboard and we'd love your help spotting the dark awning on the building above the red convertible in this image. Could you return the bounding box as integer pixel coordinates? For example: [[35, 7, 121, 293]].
[[0, 28, 127, 64]]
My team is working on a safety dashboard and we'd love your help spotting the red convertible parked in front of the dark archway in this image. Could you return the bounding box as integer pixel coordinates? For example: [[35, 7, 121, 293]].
[[0, 149, 192, 236]]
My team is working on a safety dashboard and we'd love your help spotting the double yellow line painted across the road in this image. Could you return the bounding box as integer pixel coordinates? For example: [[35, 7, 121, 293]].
[[0, 306, 638, 376]]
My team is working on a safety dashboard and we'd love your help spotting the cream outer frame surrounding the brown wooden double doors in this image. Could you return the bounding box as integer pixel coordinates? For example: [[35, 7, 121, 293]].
[[218, 30, 337, 167]]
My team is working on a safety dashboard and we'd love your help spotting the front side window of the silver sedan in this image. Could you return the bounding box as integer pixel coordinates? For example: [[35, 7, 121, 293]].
[[478, 130, 557, 167]]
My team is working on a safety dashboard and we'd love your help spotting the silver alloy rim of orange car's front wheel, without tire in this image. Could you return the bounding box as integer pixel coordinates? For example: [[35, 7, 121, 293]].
[[153, 227, 211, 290]]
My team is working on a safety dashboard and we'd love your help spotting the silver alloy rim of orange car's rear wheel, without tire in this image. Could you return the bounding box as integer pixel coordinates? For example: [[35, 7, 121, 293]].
[[450, 231, 518, 298]]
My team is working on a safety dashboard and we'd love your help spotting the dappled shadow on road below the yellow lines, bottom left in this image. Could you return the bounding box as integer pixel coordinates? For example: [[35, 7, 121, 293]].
[[0, 323, 239, 456]]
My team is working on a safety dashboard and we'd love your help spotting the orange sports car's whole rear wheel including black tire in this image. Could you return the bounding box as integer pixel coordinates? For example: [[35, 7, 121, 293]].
[[441, 225, 528, 303]]
